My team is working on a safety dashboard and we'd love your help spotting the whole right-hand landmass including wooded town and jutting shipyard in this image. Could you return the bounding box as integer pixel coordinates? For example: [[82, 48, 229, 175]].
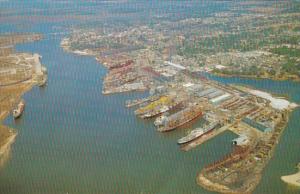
[[61, 2, 300, 193]]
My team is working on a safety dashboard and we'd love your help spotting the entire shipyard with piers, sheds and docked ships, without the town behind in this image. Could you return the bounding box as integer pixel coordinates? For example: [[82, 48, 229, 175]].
[[92, 47, 296, 193]]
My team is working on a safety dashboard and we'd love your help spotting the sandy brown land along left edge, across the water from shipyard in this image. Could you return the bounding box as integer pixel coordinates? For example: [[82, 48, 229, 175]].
[[0, 34, 47, 167]]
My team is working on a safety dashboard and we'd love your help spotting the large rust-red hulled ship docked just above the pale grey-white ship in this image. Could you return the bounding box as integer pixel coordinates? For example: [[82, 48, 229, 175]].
[[156, 104, 202, 132]]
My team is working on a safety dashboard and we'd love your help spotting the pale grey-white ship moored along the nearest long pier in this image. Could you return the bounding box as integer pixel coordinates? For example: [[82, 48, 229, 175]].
[[177, 122, 219, 145]]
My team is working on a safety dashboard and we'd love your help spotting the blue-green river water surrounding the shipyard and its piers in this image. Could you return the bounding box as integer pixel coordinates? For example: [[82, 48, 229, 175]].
[[0, 1, 300, 194]]
